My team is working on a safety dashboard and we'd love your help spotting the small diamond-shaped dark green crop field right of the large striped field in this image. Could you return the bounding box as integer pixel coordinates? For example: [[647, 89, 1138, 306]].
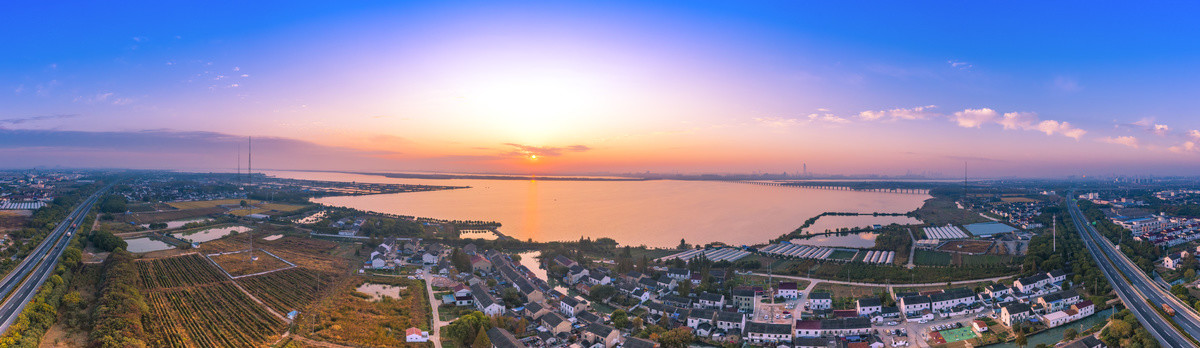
[[238, 268, 336, 313]]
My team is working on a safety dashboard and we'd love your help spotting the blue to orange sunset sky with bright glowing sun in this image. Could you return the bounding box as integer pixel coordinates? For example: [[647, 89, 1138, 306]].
[[0, 1, 1200, 176]]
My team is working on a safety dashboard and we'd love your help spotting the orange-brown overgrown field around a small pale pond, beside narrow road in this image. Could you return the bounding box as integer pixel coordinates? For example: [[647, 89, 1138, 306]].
[[295, 276, 430, 347]]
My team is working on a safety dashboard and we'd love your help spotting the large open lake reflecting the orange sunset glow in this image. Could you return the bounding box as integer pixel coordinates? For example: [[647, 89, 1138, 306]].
[[266, 172, 930, 246]]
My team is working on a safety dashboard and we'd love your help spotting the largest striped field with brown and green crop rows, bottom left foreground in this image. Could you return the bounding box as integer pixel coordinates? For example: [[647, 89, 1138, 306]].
[[144, 282, 284, 348]]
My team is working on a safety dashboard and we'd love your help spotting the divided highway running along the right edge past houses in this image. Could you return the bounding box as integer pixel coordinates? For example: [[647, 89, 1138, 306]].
[[1067, 199, 1200, 347]]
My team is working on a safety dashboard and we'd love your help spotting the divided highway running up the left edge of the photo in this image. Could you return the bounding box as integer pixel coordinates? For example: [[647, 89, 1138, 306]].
[[0, 186, 110, 334]]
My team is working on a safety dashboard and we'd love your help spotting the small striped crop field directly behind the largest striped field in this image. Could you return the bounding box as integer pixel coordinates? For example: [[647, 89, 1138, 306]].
[[137, 254, 229, 289]]
